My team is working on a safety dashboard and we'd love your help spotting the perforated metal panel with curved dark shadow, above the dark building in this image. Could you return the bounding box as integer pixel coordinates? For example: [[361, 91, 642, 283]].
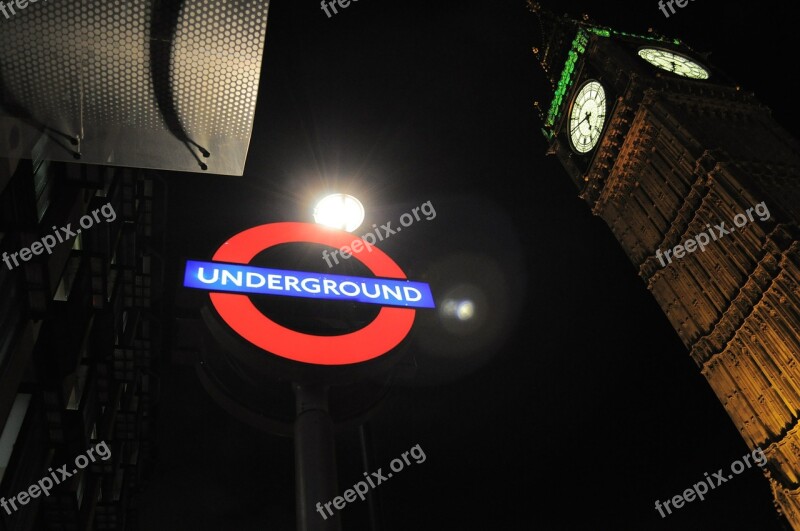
[[0, 0, 268, 175]]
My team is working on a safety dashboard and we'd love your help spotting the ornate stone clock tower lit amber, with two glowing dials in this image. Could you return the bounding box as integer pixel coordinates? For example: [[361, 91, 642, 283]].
[[529, 0, 800, 530]]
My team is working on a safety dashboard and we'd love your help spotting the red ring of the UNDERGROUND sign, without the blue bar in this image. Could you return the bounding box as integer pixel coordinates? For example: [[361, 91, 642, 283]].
[[210, 223, 416, 365]]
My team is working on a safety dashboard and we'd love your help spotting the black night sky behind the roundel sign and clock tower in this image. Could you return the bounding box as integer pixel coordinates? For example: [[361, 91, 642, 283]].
[[141, 0, 798, 531]]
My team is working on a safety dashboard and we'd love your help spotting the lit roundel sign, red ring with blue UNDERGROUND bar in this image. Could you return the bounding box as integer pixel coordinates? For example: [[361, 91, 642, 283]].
[[184, 222, 434, 365]]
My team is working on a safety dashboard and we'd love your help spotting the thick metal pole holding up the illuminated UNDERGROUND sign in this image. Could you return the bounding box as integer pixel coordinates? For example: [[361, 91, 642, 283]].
[[294, 384, 341, 531]]
